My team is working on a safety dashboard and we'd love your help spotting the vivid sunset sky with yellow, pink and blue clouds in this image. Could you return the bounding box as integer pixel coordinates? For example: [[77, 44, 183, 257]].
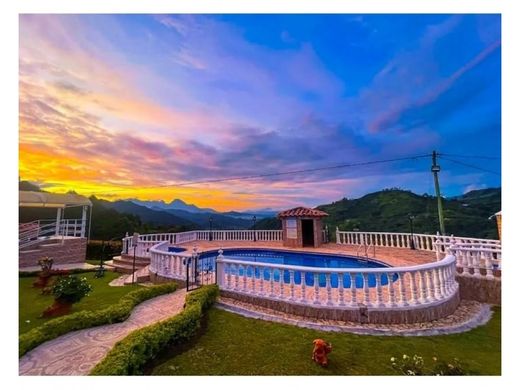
[[19, 14, 501, 211]]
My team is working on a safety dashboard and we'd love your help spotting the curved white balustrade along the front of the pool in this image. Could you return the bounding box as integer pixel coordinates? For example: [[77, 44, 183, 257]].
[[217, 253, 458, 308]]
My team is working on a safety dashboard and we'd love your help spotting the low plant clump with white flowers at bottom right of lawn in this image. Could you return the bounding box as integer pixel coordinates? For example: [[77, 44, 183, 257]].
[[390, 355, 466, 376]]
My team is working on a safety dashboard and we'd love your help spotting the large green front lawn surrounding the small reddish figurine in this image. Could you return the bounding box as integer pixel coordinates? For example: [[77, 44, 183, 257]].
[[150, 307, 501, 375]]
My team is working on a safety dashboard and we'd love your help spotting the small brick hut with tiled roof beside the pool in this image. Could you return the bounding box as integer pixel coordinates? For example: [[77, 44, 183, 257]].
[[278, 207, 328, 248]]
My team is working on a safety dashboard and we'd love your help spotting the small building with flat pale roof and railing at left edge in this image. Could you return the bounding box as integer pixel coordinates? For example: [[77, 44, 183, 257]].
[[18, 191, 92, 267]]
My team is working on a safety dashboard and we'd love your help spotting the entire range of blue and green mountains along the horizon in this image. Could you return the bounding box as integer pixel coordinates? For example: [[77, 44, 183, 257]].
[[19, 182, 501, 239]]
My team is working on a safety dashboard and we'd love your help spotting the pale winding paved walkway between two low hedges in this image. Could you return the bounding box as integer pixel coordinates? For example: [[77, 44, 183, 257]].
[[19, 289, 186, 375]]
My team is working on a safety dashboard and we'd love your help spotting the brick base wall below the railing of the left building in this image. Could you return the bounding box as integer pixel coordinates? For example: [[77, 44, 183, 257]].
[[18, 238, 87, 268]]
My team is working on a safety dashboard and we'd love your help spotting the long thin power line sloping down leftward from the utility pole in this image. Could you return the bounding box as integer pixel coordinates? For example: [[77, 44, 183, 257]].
[[88, 154, 430, 194]]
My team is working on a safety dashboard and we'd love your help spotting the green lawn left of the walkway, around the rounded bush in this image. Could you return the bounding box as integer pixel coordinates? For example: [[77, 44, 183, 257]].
[[18, 271, 141, 334]]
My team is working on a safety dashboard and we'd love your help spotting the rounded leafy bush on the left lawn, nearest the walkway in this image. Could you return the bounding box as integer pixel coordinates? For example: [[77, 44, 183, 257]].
[[43, 275, 92, 317]]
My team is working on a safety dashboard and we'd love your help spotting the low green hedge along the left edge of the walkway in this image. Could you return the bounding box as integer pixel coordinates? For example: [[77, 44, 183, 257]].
[[18, 283, 177, 356]]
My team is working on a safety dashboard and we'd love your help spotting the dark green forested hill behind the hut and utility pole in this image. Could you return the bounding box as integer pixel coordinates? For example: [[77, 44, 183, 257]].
[[257, 188, 501, 239]]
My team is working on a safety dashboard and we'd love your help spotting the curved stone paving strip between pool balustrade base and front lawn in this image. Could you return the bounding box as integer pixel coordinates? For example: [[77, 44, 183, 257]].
[[216, 298, 492, 336]]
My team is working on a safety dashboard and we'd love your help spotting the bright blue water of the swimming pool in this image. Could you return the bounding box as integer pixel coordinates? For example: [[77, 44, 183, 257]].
[[198, 249, 397, 288]]
